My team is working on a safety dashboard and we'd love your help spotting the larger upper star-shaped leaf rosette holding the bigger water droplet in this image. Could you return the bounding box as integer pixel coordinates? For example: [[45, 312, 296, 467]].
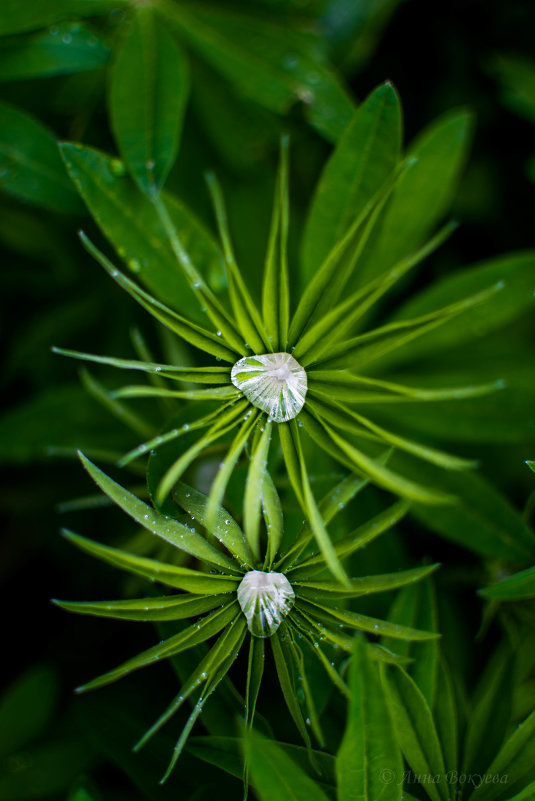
[[58, 119, 501, 581]]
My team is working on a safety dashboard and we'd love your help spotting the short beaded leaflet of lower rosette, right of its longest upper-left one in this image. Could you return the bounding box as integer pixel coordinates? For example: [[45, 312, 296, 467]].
[[173, 481, 254, 568]]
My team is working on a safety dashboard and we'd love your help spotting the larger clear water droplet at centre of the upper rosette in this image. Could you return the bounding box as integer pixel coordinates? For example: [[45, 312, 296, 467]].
[[230, 353, 308, 423]]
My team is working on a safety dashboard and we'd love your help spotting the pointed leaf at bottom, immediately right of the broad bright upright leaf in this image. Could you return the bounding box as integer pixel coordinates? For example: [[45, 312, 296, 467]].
[[381, 664, 449, 801]]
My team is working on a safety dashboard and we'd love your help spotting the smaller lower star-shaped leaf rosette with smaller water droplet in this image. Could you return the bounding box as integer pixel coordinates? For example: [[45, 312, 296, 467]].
[[56, 454, 438, 781]]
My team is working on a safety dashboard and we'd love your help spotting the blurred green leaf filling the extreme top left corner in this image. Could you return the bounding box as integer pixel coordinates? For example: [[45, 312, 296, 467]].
[[0, 0, 122, 36]]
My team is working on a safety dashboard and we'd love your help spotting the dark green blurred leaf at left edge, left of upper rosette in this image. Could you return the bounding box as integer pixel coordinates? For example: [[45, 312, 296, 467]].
[[0, 103, 82, 214]]
